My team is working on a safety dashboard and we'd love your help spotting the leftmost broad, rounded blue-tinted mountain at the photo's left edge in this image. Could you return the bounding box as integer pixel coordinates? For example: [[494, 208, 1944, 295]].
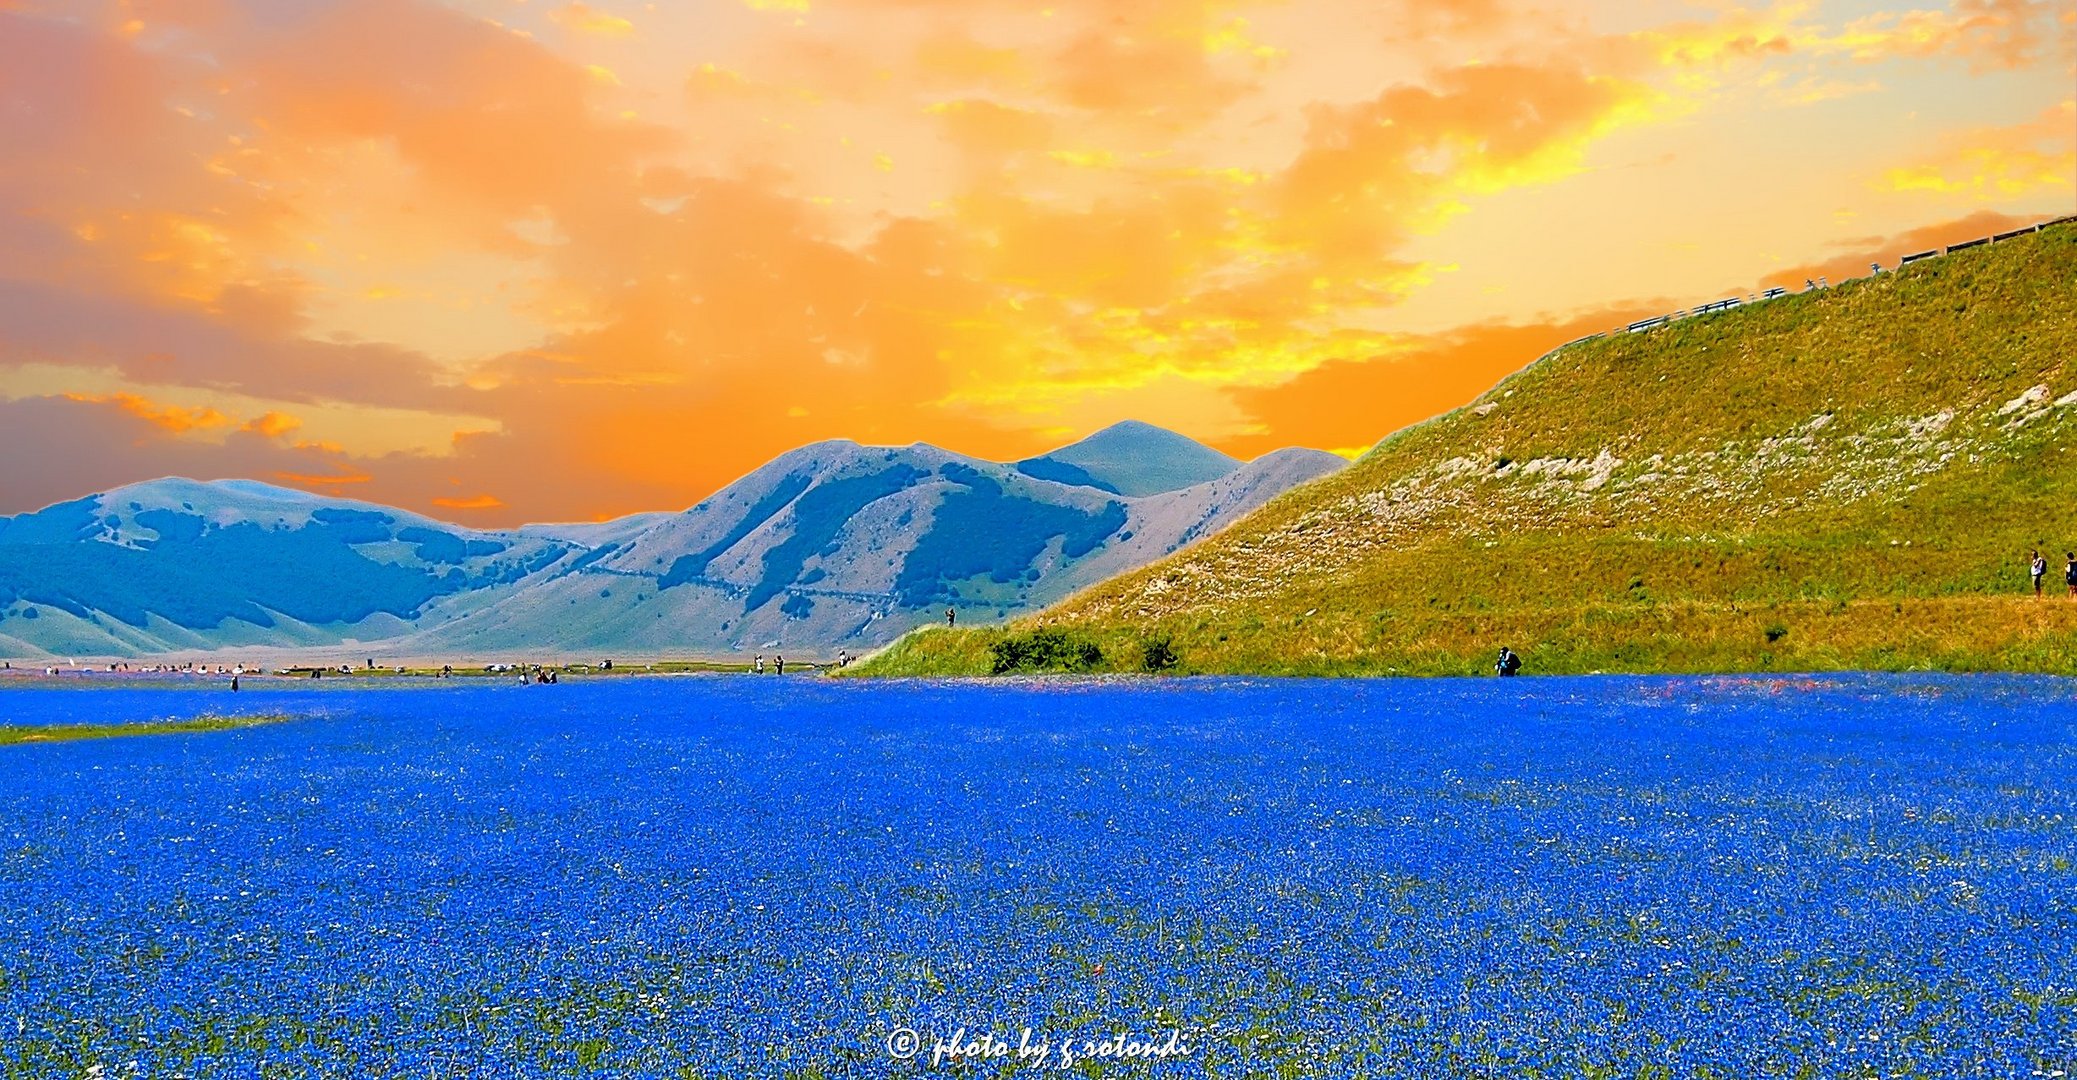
[[0, 480, 584, 656]]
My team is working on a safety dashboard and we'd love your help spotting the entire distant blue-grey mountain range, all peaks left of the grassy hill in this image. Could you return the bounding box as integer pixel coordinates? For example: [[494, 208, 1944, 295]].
[[0, 426, 1344, 658]]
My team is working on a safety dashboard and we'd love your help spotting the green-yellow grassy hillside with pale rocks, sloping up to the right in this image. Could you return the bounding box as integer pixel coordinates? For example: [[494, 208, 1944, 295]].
[[858, 224, 2077, 675]]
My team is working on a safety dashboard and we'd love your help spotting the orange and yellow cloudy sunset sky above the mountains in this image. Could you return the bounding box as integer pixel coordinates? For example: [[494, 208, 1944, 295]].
[[0, 0, 2077, 525]]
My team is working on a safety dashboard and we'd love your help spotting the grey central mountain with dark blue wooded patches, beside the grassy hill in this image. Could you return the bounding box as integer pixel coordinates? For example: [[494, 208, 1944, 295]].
[[382, 440, 1344, 656]]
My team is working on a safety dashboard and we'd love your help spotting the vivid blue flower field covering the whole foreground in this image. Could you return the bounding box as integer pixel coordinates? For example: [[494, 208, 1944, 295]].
[[0, 677, 2077, 1078]]
